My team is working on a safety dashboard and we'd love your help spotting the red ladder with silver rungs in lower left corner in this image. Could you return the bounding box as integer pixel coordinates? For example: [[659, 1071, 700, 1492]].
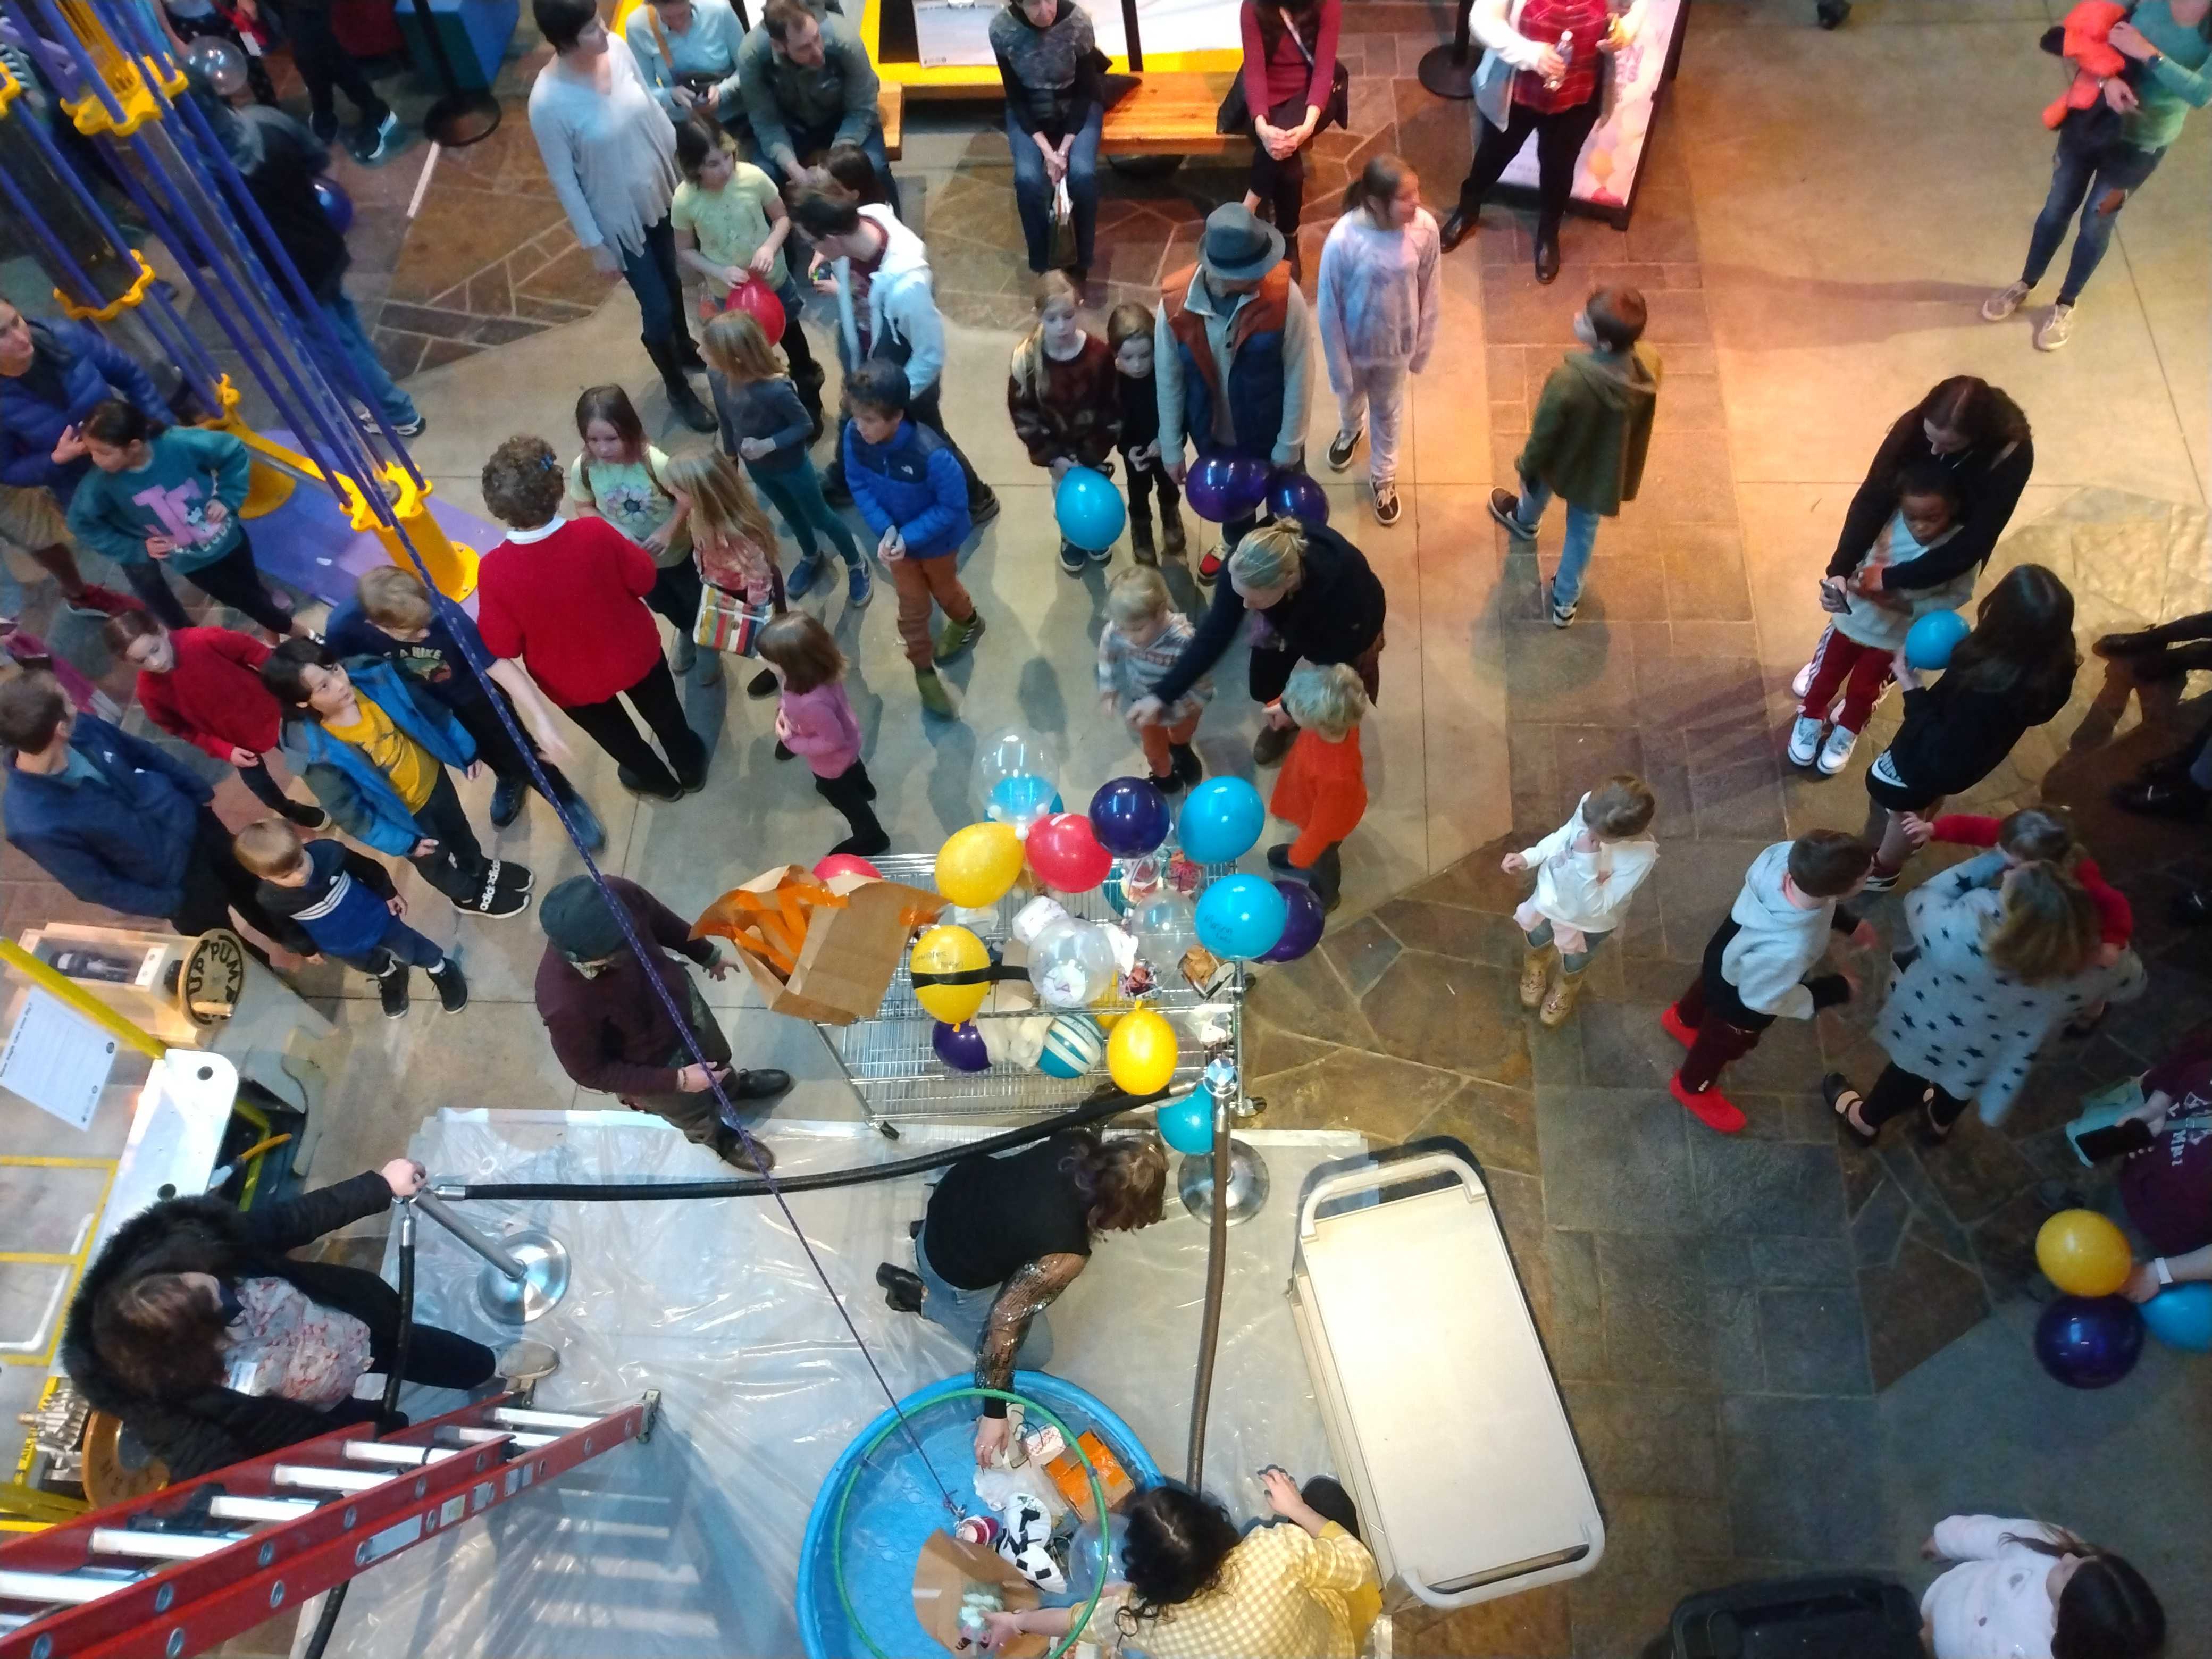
[[0, 1389, 661, 1659]]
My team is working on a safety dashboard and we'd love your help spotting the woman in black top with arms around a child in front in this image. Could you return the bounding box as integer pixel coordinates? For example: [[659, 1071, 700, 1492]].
[[1789, 374, 2035, 701]]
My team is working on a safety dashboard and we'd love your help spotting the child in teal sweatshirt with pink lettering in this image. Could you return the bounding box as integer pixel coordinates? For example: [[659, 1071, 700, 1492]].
[[55, 398, 305, 639]]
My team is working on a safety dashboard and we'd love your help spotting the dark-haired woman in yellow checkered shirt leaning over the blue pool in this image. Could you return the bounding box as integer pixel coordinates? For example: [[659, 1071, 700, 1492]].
[[989, 1469, 1382, 1659]]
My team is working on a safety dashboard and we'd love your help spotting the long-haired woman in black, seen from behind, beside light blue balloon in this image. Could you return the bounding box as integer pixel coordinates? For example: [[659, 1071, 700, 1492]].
[[1865, 564, 2082, 894]]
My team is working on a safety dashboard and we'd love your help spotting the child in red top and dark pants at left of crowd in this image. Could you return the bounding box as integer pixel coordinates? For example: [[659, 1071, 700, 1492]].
[[104, 610, 330, 830]]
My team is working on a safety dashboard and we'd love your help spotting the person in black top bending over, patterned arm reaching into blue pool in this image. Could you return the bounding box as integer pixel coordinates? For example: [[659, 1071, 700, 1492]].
[[876, 1130, 1168, 1462]]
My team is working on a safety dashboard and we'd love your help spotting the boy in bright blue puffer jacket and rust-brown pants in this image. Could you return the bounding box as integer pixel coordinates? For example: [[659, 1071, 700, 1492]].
[[845, 358, 982, 719]]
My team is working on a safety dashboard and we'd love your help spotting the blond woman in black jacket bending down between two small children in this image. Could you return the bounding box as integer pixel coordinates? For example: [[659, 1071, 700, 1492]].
[[1128, 517, 1387, 765]]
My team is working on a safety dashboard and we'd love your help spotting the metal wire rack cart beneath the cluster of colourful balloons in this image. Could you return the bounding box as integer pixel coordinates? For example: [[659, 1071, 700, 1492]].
[[816, 847, 1241, 1135]]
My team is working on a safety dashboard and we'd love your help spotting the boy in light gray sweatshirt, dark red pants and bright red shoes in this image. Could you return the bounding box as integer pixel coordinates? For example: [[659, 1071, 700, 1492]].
[[1659, 830, 1878, 1135]]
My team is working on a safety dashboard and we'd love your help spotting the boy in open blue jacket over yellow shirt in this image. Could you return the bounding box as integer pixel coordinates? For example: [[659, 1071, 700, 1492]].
[[261, 639, 531, 918]]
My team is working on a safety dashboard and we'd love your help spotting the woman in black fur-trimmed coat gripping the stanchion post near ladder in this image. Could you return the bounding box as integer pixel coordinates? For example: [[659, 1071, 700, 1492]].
[[62, 1159, 555, 1480]]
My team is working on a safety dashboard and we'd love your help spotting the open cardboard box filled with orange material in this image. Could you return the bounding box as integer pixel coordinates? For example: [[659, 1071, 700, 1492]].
[[692, 865, 944, 1026]]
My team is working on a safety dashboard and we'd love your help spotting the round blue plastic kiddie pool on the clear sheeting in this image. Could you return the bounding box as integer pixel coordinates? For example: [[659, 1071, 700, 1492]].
[[799, 1371, 1159, 1659]]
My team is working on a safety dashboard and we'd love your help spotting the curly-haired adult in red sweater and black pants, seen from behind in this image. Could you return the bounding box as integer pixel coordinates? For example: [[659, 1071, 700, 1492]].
[[475, 438, 706, 801]]
